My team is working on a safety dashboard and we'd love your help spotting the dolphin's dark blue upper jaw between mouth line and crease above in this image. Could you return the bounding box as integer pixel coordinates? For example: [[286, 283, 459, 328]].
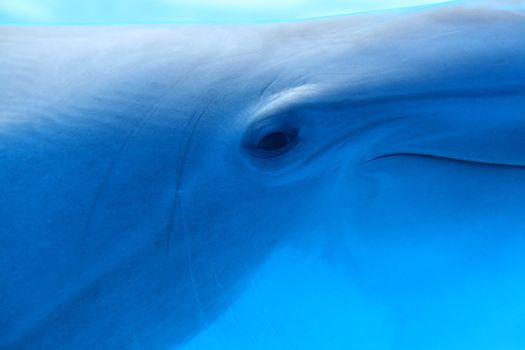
[[364, 96, 525, 167]]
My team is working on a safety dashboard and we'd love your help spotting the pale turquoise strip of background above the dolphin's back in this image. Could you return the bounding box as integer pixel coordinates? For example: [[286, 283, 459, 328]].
[[0, 0, 445, 25]]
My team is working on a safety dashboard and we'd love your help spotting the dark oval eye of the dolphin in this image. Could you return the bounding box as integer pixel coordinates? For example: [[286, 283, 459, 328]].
[[251, 128, 299, 158]]
